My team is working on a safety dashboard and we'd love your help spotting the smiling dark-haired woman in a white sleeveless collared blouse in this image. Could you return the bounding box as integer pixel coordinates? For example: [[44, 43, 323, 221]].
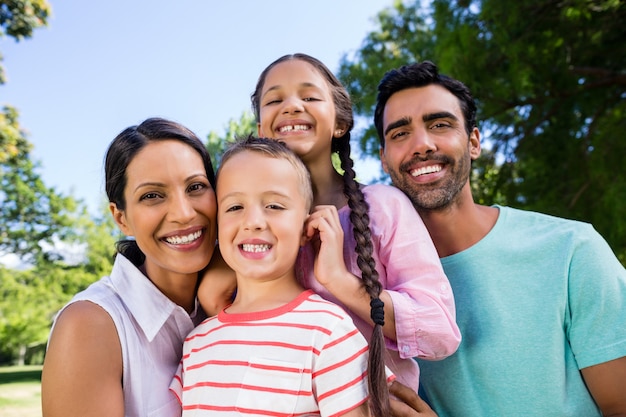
[[41, 119, 217, 417]]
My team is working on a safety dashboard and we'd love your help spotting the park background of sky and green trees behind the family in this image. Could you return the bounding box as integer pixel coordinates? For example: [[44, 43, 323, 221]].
[[0, 0, 626, 415]]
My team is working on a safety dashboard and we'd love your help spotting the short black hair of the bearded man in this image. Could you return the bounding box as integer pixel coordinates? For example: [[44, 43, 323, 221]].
[[374, 61, 476, 149]]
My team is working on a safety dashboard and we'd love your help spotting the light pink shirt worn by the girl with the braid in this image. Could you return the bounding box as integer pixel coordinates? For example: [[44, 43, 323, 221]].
[[297, 184, 461, 390]]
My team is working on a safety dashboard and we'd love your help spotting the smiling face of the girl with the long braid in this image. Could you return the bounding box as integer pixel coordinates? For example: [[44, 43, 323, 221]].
[[258, 59, 343, 164]]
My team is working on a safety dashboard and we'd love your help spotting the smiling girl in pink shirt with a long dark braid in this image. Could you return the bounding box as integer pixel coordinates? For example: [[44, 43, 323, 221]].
[[251, 54, 461, 398]]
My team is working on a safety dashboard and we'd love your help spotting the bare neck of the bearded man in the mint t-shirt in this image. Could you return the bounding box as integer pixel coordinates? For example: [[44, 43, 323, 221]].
[[418, 183, 498, 258]]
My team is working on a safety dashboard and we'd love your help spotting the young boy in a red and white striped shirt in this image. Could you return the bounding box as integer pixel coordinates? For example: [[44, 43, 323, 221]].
[[172, 137, 386, 416]]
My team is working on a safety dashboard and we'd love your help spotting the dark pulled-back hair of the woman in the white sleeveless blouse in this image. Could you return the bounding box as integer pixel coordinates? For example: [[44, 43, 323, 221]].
[[104, 117, 215, 266]]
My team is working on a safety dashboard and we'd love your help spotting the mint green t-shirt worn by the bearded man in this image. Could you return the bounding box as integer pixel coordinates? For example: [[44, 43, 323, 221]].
[[418, 206, 626, 417]]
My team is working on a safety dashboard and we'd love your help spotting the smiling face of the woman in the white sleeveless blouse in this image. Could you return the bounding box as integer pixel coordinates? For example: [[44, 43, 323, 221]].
[[111, 140, 217, 285]]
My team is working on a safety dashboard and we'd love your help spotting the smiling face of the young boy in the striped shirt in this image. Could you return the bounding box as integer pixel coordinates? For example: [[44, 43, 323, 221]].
[[217, 151, 308, 280]]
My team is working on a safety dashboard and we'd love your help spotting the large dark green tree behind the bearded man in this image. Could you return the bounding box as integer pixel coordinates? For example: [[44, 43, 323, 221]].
[[340, 0, 626, 263]]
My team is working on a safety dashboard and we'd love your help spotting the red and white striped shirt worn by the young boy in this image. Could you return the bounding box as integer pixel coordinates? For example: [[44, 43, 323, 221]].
[[170, 290, 368, 416]]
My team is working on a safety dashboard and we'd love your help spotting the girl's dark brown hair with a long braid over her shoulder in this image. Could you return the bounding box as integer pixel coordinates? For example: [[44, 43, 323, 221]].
[[250, 53, 390, 417]]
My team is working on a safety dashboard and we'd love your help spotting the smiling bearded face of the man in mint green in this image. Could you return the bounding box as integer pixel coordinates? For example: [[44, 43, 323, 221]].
[[380, 84, 480, 211]]
